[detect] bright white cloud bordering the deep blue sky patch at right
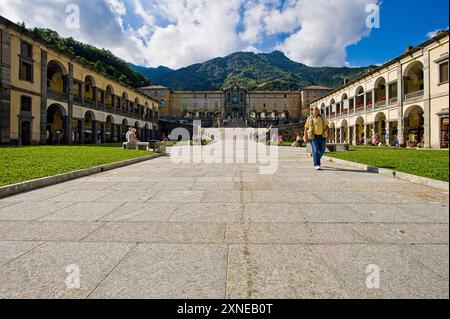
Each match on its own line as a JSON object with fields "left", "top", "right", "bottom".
{"left": 278, "top": 0, "right": 373, "bottom": 66}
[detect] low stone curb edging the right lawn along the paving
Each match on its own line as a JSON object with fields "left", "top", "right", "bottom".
{"left": 323, "top": 156, "right": 449, "bottom": 192}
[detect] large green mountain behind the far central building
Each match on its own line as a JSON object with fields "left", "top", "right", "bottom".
{"left": 130, "top": 51, "right": 375, "bottom": 91}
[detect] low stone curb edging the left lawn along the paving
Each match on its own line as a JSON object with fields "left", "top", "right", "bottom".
{"left": 0, "top": 154, "right": 162, "bottom": 198}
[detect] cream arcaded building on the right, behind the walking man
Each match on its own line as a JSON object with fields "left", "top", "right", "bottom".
{"left": 311, "top": 30, "right": 449, "bottom": 149}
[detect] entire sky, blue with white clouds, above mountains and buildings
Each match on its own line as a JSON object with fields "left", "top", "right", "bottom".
{"left": 0, "top": 0, "right": 449, "bottom": 68}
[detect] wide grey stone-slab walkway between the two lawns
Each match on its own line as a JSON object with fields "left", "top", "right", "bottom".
{"left": 0, "top": 148, "right": 449, "bottom": 298}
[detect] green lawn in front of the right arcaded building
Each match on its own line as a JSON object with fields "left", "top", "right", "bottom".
{"left": 326, "top": 148, "right": 449, "bottom": 182}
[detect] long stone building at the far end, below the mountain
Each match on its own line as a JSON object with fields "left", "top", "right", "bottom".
{"left": 139, "top": 85, "right": 330, "bottom": 127}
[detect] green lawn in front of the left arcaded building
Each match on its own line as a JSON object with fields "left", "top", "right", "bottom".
{"left": 0, "top": 144, "right": 152, "bottom": 186}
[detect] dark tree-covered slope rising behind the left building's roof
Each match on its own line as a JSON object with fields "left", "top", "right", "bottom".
{"left": 29, "top": 28, "right": 149, "bottom": 88}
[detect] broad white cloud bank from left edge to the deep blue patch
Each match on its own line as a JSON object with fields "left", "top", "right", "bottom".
{"left": 0, "top": 0, "right": 377, "bottom": 68}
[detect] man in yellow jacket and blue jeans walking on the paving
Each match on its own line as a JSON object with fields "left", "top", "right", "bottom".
{"left": 304, "top": 106, "right": 329, "bottom": 170}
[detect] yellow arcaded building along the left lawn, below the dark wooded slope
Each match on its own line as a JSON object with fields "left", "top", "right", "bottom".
{"left": 0, "top": 17, "right": 159, "bottom": 145}
